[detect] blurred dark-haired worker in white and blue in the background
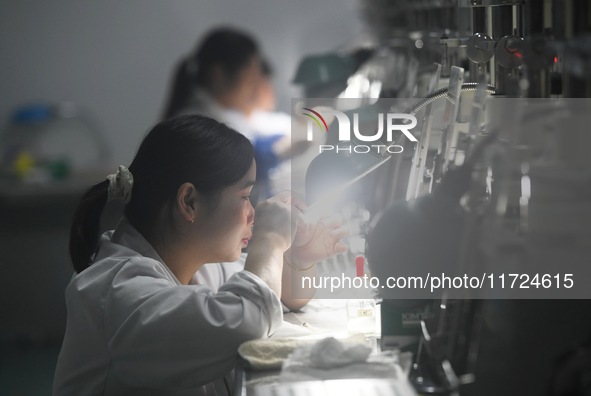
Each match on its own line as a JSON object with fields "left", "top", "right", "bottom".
{"left": 164, "top": 27, "right": 308, "bottom": 200}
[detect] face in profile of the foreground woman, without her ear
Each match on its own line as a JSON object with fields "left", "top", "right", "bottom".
{"left": 199, "top": 160, "right": 256, "bottom": 262}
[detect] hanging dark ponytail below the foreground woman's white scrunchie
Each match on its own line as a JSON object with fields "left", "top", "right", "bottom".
{"left": 70, "top": 180, "right": 109, "bottom": 273}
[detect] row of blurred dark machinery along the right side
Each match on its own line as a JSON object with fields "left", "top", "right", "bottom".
{"left": 296, "top": 0, "right": 591, "bottom": 395}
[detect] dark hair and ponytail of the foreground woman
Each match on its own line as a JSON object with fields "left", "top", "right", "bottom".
{"left": 70, "top": 115, "right": 254, "bottom": 273}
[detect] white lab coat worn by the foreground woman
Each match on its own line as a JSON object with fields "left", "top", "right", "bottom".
{"left": 53, "top": 221, "right": 282, "bottom": 396}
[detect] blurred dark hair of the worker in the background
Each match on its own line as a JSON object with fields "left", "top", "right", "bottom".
{"left": 163, "top": 27, "right": 259, "bottom": 119}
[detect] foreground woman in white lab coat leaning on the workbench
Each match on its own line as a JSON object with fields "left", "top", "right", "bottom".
{"left": 53, "top": 116, "right": 350, "bottom": 396}
